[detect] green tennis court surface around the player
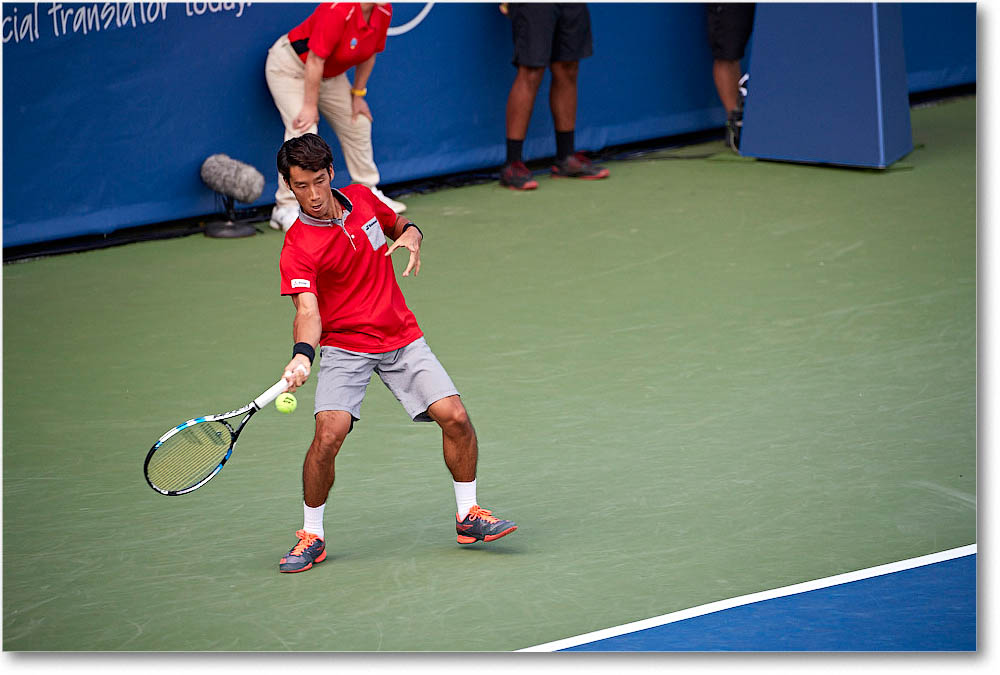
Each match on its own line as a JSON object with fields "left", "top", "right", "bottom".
{"left": 3, "top": 99, "right": 976, "bottom": 651}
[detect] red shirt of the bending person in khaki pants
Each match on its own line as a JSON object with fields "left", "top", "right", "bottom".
{"left": 288, "top": 2, "right": 392, "bottom": 77}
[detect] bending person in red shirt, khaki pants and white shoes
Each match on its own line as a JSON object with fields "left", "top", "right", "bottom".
{"left": 264, "top": 2, "right": 406, "bottom": 230}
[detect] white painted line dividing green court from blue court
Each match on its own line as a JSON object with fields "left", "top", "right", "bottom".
{"left": 517, "top": 544, "right": 976, "bottom": 652}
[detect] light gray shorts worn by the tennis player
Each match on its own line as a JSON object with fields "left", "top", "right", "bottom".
{"left": 313, "top": 337, "right": 458, "bottom": 422}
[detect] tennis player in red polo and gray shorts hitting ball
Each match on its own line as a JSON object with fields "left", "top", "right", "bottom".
{"left": 277, "top": 133, "right": 517, "bottom": 572}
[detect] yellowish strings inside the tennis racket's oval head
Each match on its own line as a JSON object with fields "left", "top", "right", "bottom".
{"left": 147, "top": 421, "right": 232, "bottom": 491}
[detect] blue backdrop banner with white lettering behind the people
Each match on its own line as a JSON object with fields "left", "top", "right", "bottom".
{"left": 2, "top": 2, "right": 976, "bottom": 247}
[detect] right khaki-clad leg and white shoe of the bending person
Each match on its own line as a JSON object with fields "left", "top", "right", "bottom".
{"left": 319, "top": 75, "right": 406, "bottom": 213}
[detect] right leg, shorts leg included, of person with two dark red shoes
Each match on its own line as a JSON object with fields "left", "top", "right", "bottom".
{"left": 549, "top": 3, "right": 609, "bottom": 180}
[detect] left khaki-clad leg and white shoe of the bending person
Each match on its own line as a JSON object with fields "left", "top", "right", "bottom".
{"left": 264, "top": 35, "right": 316, "bottom": 230}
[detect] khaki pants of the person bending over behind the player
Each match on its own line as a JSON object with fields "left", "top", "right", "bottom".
{"left": 264, "top": 34, "right": 379, "bottom": 207}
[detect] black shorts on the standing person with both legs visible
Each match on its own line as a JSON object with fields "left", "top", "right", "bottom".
{"left": 507, "top": 2, "right": 594, "bottom": 68}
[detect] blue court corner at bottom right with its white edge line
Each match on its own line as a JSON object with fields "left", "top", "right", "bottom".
{"left": 524, "top": 545, "right": 976, "bottom": 652}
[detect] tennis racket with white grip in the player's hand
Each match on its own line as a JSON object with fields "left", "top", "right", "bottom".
{"left": 142, "top": 366, "right": 305, "bottom": 495}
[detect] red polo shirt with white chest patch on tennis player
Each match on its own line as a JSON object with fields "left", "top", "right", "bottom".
{"left": 279, "top": 185, "right": 423, "bottom": 354}
